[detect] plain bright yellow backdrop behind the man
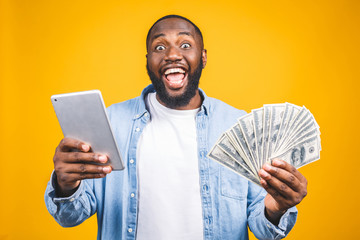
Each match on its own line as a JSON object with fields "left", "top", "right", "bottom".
{"left": 0, "top": 0, "right": 360, "bottom": 240}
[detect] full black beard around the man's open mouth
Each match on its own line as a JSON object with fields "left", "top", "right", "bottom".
{"left": 146, "top": 58, "right": 203, "bottom": 109}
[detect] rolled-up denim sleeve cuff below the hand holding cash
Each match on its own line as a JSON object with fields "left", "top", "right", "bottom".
{"left": 247, "top": 183, "right": 297, "bottom": 239}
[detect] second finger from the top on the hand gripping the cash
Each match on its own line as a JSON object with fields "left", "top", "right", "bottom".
{"left": 263, "top": 163, "right": 301, "bottom": 191}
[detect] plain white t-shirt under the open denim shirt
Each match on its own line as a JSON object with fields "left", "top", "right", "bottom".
{"left": 136, "top": 93, "right": 203, "bottom": 240}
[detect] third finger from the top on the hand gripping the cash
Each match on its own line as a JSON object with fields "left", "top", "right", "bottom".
{"left": 259, "top": 169, "right": 296, "bottom": 199}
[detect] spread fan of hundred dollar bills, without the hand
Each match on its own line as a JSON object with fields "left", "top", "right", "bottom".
{"left": 208, "top": 103, "right": 321, "bottom": 185}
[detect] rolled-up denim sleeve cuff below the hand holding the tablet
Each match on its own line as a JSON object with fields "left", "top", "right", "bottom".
{"left": 45, "top": 172, "right": 96, "bottom": 227}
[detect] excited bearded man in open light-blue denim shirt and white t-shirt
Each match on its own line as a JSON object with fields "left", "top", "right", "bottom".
{"left": 45, "top": 15, "right": 307, "bottom": 240}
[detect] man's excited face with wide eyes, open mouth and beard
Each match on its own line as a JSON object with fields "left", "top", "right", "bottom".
{"left": 147, "top": 18, "right": 206, "bottom": 108}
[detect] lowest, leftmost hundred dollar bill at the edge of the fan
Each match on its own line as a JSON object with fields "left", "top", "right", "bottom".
{"left": 208, "top": 145, "right": 261, "bottom": 186}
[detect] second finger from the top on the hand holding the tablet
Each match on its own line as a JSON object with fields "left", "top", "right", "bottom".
{"left": 55, "top": 152, "right": 108, "bottom": 163}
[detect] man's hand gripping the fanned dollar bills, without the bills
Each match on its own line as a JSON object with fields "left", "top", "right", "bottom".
{"left": 259, "top": 158, "right": 307, "bottom": 225}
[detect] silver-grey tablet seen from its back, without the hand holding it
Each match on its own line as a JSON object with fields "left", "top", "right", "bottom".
{"left": 51, "top": 90, "right": 124, "bottom": 170}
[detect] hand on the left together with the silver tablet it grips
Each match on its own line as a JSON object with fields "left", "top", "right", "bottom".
{"left": 51, "top": 90, "right": 124, "bottom": 196}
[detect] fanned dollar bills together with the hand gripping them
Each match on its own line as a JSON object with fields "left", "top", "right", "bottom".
{"left": 208, "top": 103, "right": 321, "bottom": 224}
